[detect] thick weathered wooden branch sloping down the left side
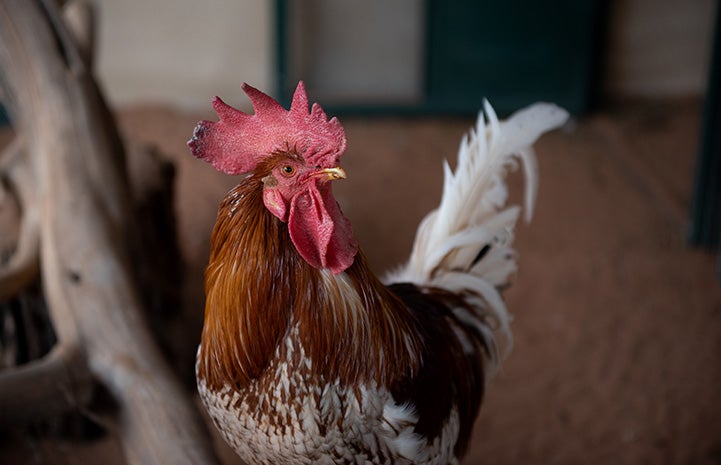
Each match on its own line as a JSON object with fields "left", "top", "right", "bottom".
{"left": 0, "top": 0, "right": 217, "bottom": 464}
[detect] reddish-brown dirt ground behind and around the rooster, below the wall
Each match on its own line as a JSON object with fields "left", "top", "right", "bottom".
{"left": 0, "top": 96, "right": 721, "bottom": 465}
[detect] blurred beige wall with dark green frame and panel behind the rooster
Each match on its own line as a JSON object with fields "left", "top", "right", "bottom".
{"left": 96, "top": 0, "right": 717, "bottom": 113}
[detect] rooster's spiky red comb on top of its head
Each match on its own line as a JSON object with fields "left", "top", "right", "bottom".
{"left": 188, "top": 81, "right": 346, "bottom": 174}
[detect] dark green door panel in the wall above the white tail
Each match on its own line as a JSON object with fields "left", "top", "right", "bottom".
{"left": 426, "top": 0, "right": 604, "bottom": 114}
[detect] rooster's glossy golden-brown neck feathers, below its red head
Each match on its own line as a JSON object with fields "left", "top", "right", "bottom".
{"left": 198, "top": 176, "right": 421, "bottom": 389}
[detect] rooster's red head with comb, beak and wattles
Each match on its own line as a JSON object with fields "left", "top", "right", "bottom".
{"left": 188, "top": 82, "right": 358, "bottom": 273}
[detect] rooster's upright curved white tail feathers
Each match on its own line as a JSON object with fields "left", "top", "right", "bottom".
{"left": 385, "top": 101, "right": 568, "bottom": 374}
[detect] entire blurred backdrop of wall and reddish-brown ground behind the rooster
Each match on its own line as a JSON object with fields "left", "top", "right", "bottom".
{"left": 0, "top": 0, "right": 721, "bottom": 465}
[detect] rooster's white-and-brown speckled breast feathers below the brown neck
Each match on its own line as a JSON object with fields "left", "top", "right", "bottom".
{"left": 198, "top": 327, "right": 458, "bottom": 465}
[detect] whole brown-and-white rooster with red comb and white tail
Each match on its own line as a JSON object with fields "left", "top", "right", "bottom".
{"left": 188, "top": 82, "right": 567, "bottom": 465}
